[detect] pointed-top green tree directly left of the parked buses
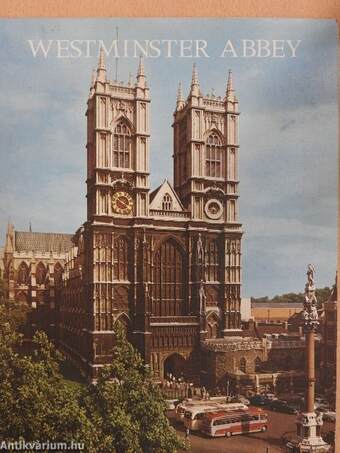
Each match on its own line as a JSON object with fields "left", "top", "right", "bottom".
{"left": 85, "top": 329, "right": 185, "bottom": 453}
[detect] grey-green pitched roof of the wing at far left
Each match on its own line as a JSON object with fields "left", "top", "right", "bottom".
{"left": 15, "top": 231, "right": 73, "bottom": 253}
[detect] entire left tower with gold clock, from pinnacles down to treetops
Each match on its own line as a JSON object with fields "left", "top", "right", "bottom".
{"left": 78, "top": 50, "right": 150, "bottom": 375}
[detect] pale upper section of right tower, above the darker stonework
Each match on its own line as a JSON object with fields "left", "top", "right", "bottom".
{"left": 173, "top": 65, "right": 239, "bottom": 223}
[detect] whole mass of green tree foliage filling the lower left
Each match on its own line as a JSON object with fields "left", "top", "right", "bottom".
{"left": 0, "top": 274, "right": 184, "bottom": 453}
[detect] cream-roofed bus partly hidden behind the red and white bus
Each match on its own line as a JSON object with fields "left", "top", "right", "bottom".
{"left": 184, "top": 401, "right": 248, "bottom": 431}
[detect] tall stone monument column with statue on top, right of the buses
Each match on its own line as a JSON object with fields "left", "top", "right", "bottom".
{"left": 287, "top": 264, "right": 330, "bottom": 453}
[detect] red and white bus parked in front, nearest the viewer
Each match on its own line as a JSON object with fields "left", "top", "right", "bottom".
{"left": 200, "top": 407, "right": 268, "bottom": 437}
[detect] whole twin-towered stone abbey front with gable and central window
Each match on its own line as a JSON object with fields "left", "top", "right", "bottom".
{"left": 56, "top": 52, "right": 242, "bottom": 379}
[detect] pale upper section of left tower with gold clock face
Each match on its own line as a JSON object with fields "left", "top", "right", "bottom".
{"left": 87, "top": 50, "right": 150, "bottom": 223}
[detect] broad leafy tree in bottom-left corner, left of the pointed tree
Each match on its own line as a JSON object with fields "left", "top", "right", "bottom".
{"left": 0, "top": 323, "right": 101, "bottom": 453}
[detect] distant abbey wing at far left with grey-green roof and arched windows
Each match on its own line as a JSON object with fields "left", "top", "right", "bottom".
{"left": 1, "top": 224, "right": 72, "bottom": 338}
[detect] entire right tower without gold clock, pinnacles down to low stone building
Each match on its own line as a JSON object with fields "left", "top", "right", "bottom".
{"left": 173, "top": 64, "right": 242, "bottom": 336}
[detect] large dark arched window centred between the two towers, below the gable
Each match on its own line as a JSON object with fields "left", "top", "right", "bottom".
{"left": 153, "top": 239, "right": 183, "bottom": 316}
